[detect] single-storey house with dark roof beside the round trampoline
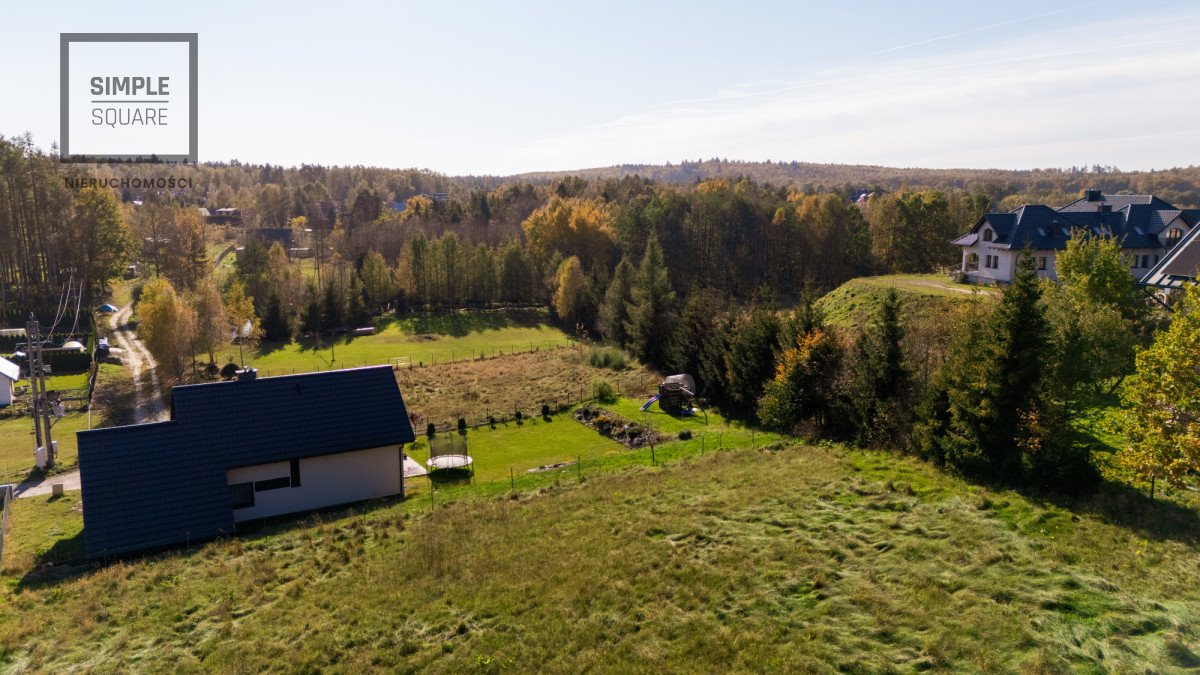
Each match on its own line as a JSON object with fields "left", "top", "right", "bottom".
{"left": 78, "top": 366, "right": 414, "bottom": 557}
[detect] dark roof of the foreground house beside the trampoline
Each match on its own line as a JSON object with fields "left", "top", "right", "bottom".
{"left": 78, "top": 366, "right": 414, "bottom": 557}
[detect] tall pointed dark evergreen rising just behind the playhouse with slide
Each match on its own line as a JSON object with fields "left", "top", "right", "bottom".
{"left": 625, "top": 233, "right": 676, "bottom": 365}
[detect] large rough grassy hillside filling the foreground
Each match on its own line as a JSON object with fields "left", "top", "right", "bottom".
{"left": 0, "top": 432, "right": 1200, "bottom": 671}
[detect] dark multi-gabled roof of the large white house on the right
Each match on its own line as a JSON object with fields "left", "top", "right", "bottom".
{"left": 954, "top": 191, "right": 1198, "bottom": 250}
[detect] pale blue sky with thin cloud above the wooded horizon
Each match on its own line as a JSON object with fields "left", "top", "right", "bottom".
{"left": 0, "top": 0, "right": 1200, "bottom": 175}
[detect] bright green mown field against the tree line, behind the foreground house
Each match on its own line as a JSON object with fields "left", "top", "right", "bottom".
{"left": 242, "top": 310, "right": 574, "bottom": 375}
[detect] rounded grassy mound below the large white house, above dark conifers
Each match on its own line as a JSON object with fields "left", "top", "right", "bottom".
{"left": 817, "top": 274, "right": 996, "bottom": 327}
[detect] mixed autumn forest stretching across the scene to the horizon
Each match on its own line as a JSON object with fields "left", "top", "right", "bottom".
{"left": 0, "top": 132, "right": 1200, "bottom": 489}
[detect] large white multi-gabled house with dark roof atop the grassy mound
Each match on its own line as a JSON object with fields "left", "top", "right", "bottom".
{"left": 954, "top": 190, "right": 1200, "bottom": 283}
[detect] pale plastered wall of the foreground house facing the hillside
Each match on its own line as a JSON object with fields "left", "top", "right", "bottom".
{"left": 226, "top": 446, "right": 403, "bottom": 522}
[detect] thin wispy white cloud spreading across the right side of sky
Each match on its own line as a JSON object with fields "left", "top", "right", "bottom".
{"left": 490, "top": 16, "right": 1200, "bottom": 172}
